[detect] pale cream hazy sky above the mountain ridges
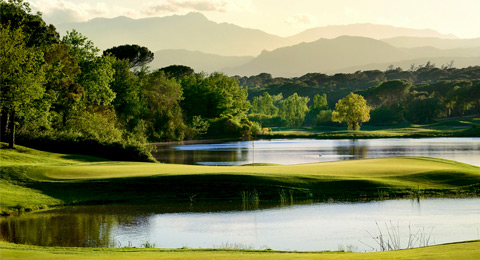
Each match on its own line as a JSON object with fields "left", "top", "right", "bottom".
{"left": 27, "top": 0, "right": 480, "bottom": 38}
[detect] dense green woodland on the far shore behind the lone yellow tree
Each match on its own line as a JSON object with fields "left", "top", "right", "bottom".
{"left": 244, "top": 66, "right": 480, "bottom": 126}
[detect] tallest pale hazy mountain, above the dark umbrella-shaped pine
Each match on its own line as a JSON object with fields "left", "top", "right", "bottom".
{"left": 57, "top": 13, "right": 292, "bottom": 56}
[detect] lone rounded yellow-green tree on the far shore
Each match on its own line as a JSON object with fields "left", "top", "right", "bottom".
{"left": 332, "top": 93, "right": 370, "bottom": 130}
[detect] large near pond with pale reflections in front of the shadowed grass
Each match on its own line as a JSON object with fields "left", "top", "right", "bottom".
{"left": 0, "top": 198, "right": 480, "bottom": 252}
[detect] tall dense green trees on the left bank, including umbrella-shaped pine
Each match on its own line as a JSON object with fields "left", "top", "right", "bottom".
{"left": 0, "top": 0, "right": 259, "bottom": 160}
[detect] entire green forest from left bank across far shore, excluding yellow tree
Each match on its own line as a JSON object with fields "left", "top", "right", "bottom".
{"left": 0, "top": 0, "right": 480, "bottom": 160}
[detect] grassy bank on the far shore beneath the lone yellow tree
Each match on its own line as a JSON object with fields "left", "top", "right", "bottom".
{"left": 262, "top": 117, "right": 480, "bottom": 139}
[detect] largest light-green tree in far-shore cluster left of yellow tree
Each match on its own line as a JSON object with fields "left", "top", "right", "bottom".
{"left": 279, "top": 93, "right": 310, "bottom": 126}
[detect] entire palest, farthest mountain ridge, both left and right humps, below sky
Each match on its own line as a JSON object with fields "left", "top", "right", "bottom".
{"left": 57, "top": 12, "right": 464, "bottom": 56}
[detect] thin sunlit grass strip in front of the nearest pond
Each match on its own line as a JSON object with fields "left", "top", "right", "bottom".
{"left": 0, "top": 241, "right": 480, "bottom": 260}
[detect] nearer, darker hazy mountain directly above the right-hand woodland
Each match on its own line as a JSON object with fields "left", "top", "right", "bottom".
{"left": 222, "top": 36, "right": 480, "bottom": 77}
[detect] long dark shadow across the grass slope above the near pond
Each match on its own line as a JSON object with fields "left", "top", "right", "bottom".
{"left": 27, "top": 174, "right": 404, "bottom": 204}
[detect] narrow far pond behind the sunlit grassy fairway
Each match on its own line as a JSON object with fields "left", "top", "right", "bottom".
{"left": 154, "top": 137, "right": 480, "bottom": 166}
